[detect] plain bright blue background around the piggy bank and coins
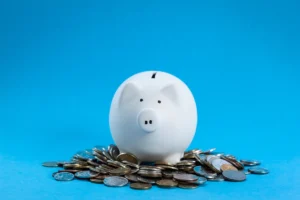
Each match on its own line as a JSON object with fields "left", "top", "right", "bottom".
{"left": 0, "top": 0, "right": 300, "bottom": 200}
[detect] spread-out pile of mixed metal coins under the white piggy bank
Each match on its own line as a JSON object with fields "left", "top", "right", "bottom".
{"left": 43, "top": 144, "right": 269, "bottom": 190}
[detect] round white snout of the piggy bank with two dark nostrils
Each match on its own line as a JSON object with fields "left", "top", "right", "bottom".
{"left": 138, "top": 109, "right": 158, "bottom": 133}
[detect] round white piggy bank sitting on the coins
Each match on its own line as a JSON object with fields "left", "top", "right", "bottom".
{"left": 109, "top": 71, "right": 197, "bottom": 164}
